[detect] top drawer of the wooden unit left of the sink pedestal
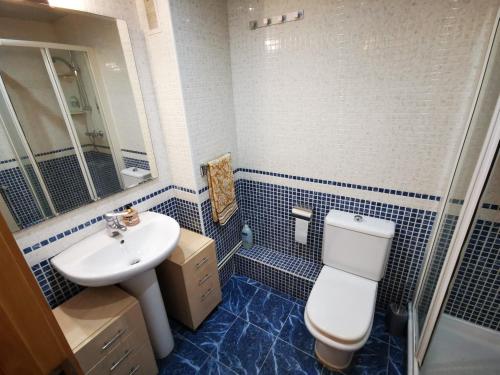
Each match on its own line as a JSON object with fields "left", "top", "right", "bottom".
{"left": 75, "top": 304, "right": 143, "bottom": 372}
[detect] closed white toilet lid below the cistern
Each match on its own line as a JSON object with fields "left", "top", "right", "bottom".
{"left": 306, "top": 266, "right": 377, "bottom": 343}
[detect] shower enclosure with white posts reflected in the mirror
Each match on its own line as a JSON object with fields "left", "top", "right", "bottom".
{"left": 0, "top": 39, "right": 124, "bottom": 229}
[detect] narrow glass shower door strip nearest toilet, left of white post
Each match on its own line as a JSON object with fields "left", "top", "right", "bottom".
{"left": 414, "top": 18, "right": 500, "bottom": 368}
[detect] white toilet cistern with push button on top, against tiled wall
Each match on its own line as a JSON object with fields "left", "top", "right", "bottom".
{"left": 323, "top": 210, "right": 396, "bottom": 281}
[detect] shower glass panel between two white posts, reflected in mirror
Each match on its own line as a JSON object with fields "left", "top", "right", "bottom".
{"left": 0, "top": 46, "right": 92, "bottom": 212}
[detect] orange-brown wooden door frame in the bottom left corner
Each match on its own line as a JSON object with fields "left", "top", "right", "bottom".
{"left": 0, "top": 214, "right": 83, "bottom": 375}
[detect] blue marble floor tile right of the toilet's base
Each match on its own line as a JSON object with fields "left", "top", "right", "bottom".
{"left": 342, "top": 337, "right": 389, "bottom": 375}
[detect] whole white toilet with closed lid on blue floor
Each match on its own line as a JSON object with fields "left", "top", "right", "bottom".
{"left": 304, "top": 210, "right": 396, "bottom": 369}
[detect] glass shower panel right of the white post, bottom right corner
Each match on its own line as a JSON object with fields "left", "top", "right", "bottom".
{"left": 420, "top": 154, "right": 500, "bottom": 375}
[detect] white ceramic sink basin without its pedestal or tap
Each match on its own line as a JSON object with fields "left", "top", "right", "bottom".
{"left": 52, "top": 212, "right": 180, "bottom": 287}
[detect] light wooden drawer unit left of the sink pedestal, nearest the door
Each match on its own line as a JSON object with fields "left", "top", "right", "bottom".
{"left": 53, "top": 286, "right": 158, "bottom": 375}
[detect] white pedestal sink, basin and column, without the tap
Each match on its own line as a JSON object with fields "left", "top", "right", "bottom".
{"left": 52, "top": 212, "right": 180, "bottom": 358}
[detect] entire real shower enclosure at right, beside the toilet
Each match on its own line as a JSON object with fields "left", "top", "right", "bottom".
{"left": 408, "top": 17, "right": 500, "bottom": 375}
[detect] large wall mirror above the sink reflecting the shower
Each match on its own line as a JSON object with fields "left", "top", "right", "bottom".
{"left": 0, "top": 2, "right": 157, "bottom": 231}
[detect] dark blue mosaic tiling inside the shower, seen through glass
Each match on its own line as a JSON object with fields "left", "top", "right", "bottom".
{"left": 417, "top": 206, "right": 500, "bottom": 331}
